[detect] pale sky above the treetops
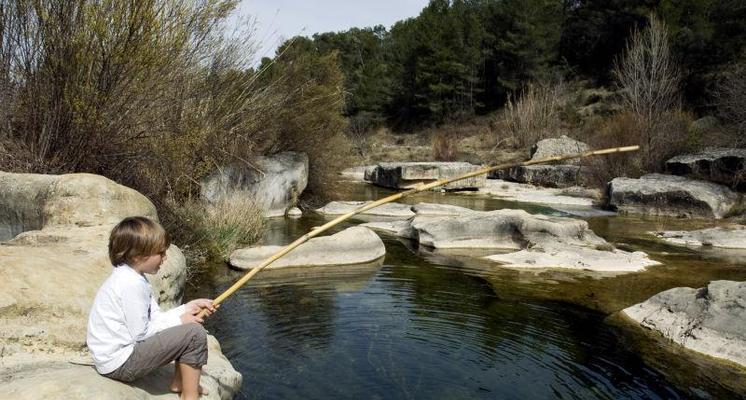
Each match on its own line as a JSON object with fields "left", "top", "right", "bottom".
{"left": 238, "top": 0, "right": 428, "bottom": 61}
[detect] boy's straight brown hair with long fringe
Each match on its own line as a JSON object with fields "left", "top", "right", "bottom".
{"left": 109, "top": 217, "right": 171, "bottom": 267}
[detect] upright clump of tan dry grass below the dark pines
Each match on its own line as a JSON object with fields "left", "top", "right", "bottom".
{"left": 503, "top": 81, "right": 569, "bottom": 147}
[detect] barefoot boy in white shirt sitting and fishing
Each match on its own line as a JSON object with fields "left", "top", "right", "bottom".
{"left": 86, "top": 217, "right": 215, "bottom": 399}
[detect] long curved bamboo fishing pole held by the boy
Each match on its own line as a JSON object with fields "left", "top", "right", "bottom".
{"left": 198, "top": 146, "right": 640, "bottom": 317}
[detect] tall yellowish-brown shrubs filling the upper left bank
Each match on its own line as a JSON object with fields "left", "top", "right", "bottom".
{"left": 0, "top": 0, "right": 350, "bottom": 255}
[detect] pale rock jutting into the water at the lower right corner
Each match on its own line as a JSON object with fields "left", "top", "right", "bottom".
{"left": 622, "top": 281, "right": 746, "bottom": 367}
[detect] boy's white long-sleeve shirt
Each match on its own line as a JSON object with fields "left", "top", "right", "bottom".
{"left": 86, "top": 264, "right": 186, "bottom": 374}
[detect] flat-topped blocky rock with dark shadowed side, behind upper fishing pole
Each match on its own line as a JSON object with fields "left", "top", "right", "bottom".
{"left": 365, "top": 162, "right": 486, "bottom": 190}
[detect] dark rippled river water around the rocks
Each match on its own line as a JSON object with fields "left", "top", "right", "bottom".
{"left": 188, "top": 183, "right": 746, "bottom": 399}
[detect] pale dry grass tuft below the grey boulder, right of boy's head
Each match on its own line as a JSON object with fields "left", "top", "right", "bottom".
{"left": 163, "top": 194, "right": 265, "bottom": 260}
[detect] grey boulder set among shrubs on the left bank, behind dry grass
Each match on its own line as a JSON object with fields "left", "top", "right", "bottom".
{"left": 200, "top": 152, "right": 308, "bottom": 217}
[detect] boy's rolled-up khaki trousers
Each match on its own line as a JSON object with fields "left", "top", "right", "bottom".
{"left": 104, "top": 323, "right": 207, "bottom": 382}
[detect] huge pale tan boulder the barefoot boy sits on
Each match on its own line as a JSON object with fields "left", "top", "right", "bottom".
{"left": 0, "top": 173, "right": 240, "bottom": 399}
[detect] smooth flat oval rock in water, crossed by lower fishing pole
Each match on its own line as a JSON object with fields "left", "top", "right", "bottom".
{"left": 230, "top": 227, "right": 386, "bottom": 270}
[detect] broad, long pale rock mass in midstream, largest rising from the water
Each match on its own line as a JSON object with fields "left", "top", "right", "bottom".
{"left": 363, "top": 205, "right": 659, "bottom": 273}
